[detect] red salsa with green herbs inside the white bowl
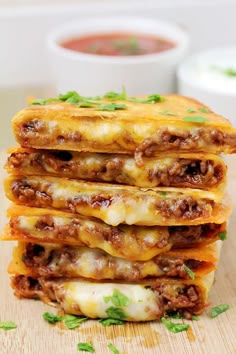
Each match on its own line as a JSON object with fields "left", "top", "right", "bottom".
{"left": 60, "top": 33, "right": 176, "bottom": 56}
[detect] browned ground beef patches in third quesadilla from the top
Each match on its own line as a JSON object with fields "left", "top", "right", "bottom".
{"left": 11, "top": 179, "right": 214, "bottom": 220}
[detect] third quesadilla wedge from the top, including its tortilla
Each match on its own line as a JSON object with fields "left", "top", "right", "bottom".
{"left": 5, "top": 176, "right": 230, "bottom": 226}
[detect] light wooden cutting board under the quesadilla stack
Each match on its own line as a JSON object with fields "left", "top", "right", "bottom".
{"left": 0, "top": 152, "right": 236, "bottom": 354}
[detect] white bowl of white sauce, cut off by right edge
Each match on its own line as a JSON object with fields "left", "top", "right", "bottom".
{"left": 177, "top": 47, "right": 236, "bottom": 126}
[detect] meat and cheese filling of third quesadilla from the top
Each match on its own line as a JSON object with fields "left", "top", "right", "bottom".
{"left": 11, "top": 177, "right": 215, "bottom": 226}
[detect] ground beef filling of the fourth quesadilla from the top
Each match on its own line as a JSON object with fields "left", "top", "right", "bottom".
{"left": 9, "top": 214, "right": 222, "bottom": 250}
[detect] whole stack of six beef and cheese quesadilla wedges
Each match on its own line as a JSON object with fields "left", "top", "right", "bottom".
{"left": 2, "top": 92, "right": 236, "bottom": 321}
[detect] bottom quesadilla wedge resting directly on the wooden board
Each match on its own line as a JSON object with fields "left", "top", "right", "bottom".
{"left": 11, "top": 272, "right": 214, "bottom": 321}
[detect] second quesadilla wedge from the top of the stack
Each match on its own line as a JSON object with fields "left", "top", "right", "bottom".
{"left": 5, "top": 147, "right": 227, "bottom": 190}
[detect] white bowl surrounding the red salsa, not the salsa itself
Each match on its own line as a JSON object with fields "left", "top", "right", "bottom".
{"left": 47, "top": 17, "right": 188, "bottom": 96}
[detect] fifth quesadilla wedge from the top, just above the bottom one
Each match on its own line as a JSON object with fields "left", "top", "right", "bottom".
{"left": 8, "top": 242, "right": 218, "bottom": 282}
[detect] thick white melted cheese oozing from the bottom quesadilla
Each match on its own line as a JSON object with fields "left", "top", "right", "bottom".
{"left": 55, "top": 281, "right": 160, "bottom": 321}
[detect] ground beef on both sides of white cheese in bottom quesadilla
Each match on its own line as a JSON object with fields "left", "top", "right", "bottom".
{"left": 11, "top": 275, "right": 203, "bottom": 319}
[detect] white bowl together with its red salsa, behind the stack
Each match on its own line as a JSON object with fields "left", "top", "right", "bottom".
{"left": 47, "top": 17, "right": 188, "bottom": 95}
